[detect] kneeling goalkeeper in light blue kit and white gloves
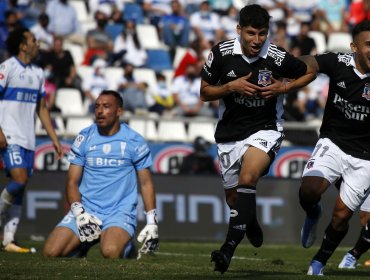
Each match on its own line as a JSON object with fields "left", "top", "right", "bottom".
{"left": 44, "top": 90, "right": 158, "bottom": 258}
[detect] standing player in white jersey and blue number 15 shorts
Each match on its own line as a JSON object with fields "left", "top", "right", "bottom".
{"left": 0, "top": 28, "right": 63, "bottom": 253}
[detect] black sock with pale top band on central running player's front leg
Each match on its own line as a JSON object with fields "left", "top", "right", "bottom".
{"left": 221, "top": 185, "right": 256, "bottom": 256}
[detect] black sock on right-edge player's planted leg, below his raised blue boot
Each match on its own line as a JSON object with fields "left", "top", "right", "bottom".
{"left": 313, "top": 224, "right": 348, "bottom": 265}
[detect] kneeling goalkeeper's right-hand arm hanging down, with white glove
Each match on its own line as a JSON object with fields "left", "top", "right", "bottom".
{"left": 137, "top": 168, "right": 159, "bottom": 254}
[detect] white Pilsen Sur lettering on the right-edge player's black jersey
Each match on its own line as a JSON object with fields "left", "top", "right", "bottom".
{"left": 333, "top": 93, "right": 370, "bottom": 121}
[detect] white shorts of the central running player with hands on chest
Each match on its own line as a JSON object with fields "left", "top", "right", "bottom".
{"left": 217, "top": 130, "right": 284, "bottom": 189}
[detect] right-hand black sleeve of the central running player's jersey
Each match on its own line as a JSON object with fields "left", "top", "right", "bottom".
{"left": 277, "top": 48, "right": 307, "bottom": 79}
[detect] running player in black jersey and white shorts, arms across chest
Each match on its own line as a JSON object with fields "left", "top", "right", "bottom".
{"left": 200, "top": 5, "right": 315, "bottom": 273}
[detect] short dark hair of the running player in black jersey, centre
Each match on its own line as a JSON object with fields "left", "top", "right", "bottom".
{"left": 239, "top": 4, "right": 271, "bottom": 28}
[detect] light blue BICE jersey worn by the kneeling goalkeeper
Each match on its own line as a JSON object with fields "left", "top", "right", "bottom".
{"left": 68, "top": 124, "right": 152, "bottom": 217}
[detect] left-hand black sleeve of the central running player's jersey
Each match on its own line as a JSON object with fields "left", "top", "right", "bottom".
{"left": 200, "top": 45, "right": 222, "bottom": 85}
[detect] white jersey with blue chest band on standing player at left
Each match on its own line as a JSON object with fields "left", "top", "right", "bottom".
{"left": 0, "top": 57, "right": 45, "bottom": 150}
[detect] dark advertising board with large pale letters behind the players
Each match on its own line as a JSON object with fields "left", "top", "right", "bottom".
{"left": 0, "top": 171, "right": 360, "bottom": 245}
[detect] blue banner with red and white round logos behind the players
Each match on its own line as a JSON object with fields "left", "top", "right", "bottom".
{"left": 35, "top": 138, "right": 313, "bottom": 178}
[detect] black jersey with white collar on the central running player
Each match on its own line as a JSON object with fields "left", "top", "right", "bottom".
{"left": 201, "top": 38, "right": 307, "bottom": 143}
